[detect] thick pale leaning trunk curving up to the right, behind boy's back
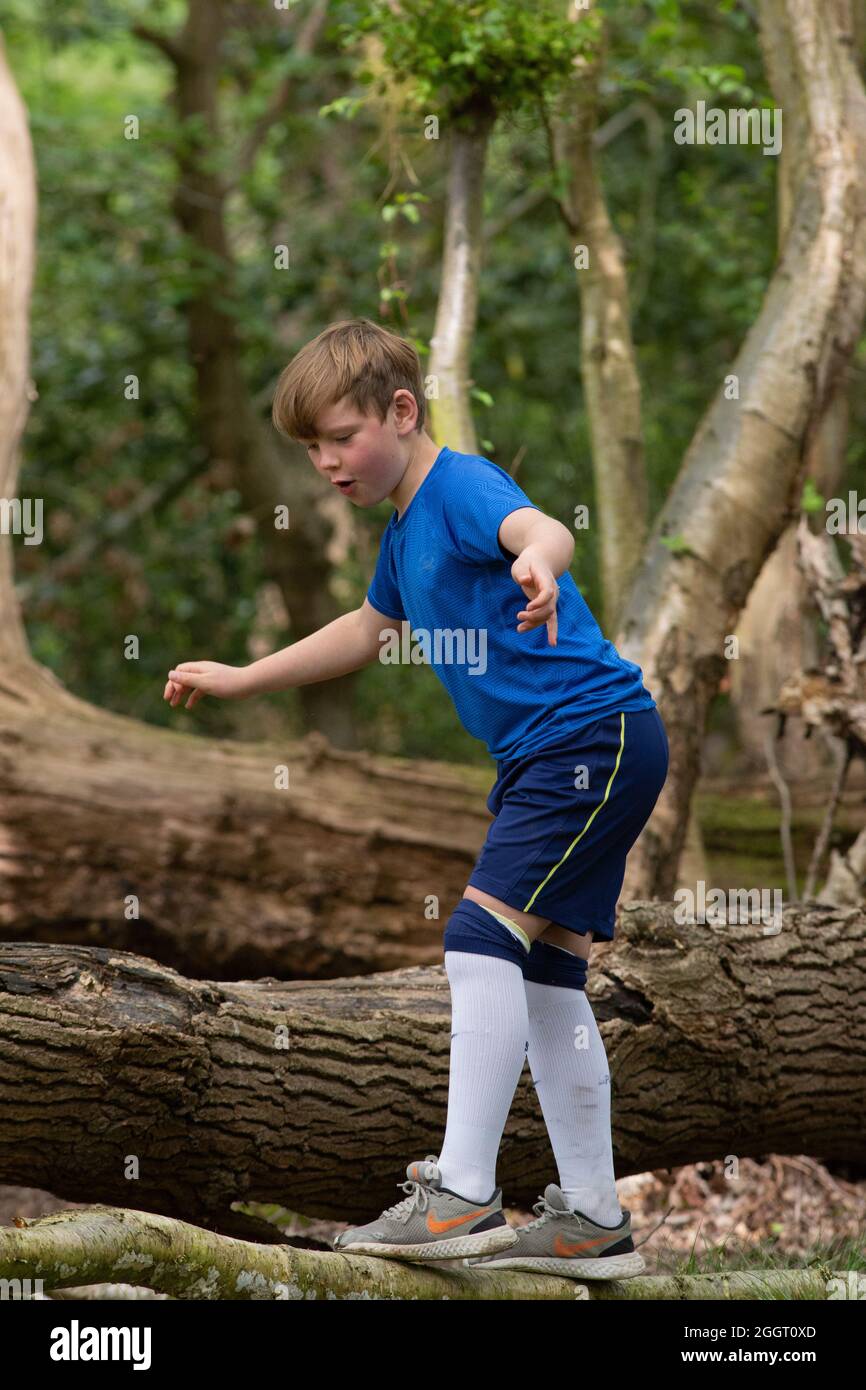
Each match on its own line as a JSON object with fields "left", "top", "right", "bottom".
{"left": 616, "top": 0, "right": 866, "bottom": 898}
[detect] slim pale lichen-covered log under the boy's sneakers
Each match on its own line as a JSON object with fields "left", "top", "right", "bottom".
{"left": 0, "top": 1207, "right": 849, "bottom": 1302}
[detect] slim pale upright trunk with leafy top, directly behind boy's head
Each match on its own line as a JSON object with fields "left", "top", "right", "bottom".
{"left": 430, "top": 107, "right": 495, "bottom": 453}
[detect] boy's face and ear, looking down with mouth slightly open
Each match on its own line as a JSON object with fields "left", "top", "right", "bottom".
{"left": 300, "top": 391, "right": 417, "bottom": 507}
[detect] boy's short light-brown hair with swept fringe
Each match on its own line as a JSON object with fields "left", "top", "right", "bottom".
{"left": 271, "top": 318, "right": 425, "bottom": 439}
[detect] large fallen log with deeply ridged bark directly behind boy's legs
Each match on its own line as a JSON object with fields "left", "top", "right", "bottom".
{"left": 0, "top": 902, "right": 866, "bottom": 1230}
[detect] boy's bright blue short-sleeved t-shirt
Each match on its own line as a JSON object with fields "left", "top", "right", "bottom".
{"left": 367, "top": 448, "right": 655, "bottom": 762}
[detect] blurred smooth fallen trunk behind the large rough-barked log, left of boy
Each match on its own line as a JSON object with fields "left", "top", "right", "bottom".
{"left": 0, "top": 717, "right": 491, "bottom": 980}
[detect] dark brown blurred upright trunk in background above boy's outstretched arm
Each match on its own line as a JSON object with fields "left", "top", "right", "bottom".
{"left": 132, "top": 0, "right": 357, "bottom": 748}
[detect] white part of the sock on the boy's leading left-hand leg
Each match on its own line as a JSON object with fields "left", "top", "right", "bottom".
{"left": 438, "top": 951, "right": 528, "bottom": 1202}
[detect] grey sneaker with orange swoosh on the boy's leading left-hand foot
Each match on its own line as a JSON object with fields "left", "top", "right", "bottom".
{"left": 332, "top": 1154, "right": 517, "bottom": 1259}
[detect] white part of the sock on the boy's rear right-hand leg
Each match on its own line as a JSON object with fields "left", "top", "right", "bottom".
{"left": 524, "top": 980, "right": 623, "bottom": 1226}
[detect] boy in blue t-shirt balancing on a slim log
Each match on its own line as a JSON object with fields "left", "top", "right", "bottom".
{"left": 165, "top": 318, "right": 667, "bottom": 1279}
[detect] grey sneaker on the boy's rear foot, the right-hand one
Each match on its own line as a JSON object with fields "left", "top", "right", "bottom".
{"left": 463, "top": 1183, "right": 646, "bottom": 1279}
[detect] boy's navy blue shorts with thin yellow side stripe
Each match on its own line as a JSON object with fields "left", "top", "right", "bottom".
{"left": 468, "top": 706, "right": 669, "bottom": 941}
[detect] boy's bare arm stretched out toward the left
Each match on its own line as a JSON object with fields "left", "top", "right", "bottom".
{"left": 164, "top": 599, "right": 400, "bottom": 709}
